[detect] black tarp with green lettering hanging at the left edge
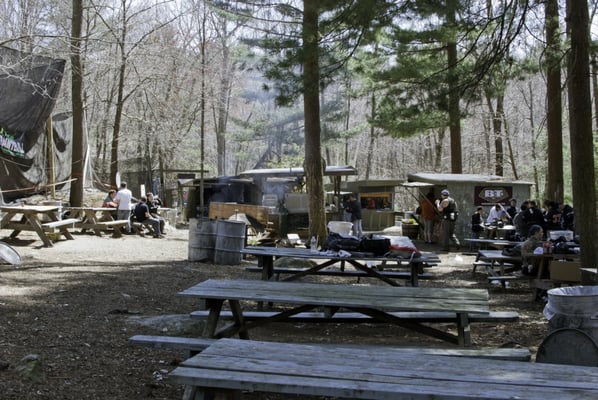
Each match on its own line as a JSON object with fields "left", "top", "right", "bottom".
{"left": 0, "top": 46, "right": 70, "bottom": 200}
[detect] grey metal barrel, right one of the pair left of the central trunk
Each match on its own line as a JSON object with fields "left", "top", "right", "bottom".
{"left": 214, "top": 219, "right": 245, "bottom": 265}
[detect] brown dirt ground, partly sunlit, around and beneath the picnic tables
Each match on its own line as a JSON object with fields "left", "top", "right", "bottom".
{"left": 0, "top": 222, "right": 547, "bottom": 400}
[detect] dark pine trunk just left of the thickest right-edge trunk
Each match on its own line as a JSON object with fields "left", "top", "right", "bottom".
{"left": 544, "top": 0, "right": 564, "bottom": 203}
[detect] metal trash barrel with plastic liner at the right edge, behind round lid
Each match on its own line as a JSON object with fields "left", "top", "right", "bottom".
{"left": 544, "top": 286, "right": 598, "bottom": 342}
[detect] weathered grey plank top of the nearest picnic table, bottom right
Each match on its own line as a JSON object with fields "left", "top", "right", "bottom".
{"left": 169, "top": 339, "right": 598, "bottom": 400}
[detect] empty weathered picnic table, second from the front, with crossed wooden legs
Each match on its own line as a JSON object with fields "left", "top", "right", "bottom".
{"left": 179, "top": 279, "right": 490, "bottom": 347}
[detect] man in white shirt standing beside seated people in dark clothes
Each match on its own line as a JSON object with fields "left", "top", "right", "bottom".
{"left": 102, "top": 182, "right": 166, "bottom": 238}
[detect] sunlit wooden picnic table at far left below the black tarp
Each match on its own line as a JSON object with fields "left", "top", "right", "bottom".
{"left": 0, "top": 204, "right": 79, "bottom": 247}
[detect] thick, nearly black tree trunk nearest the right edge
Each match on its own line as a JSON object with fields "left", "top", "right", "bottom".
{"left": 566, "top": 0, "right": 598, "bottom": 268}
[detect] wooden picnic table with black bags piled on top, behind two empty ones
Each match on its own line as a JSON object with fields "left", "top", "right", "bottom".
{"left": 241, "top": 246, "right": 439, "bottom": 286}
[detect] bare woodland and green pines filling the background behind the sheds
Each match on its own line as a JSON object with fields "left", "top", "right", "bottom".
{"left": 0, "top": 0, "right": 598, "bottom": 266}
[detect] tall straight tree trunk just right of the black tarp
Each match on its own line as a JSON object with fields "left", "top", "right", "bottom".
{"left": 69, "top": 0, "right": 84, "bottom": 207}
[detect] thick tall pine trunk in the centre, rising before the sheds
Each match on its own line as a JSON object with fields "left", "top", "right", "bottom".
{"left": 303, "top": 0, "right": 326, "bottom": 244}
